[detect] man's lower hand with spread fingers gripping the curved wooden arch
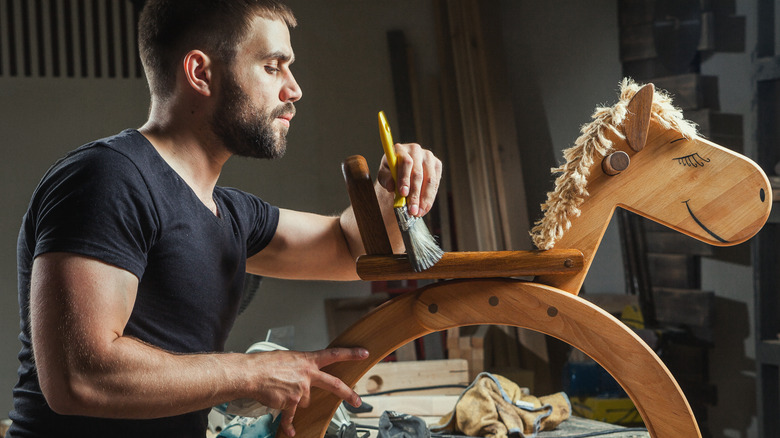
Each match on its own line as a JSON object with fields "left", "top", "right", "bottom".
{"left": 251, "top": 348, "right": 368, "bottom": 437}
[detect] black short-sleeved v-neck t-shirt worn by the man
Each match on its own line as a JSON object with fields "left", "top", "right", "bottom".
{"left": 9, "top": 130, "right": 279, "bottom": 437}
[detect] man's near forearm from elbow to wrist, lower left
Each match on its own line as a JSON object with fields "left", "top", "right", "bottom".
{"left": 38, "top": 336, "right": 260, "bottom": 418}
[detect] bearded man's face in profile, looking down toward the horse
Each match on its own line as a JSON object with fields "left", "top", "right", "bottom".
{"left": 211, "top": 17, "right": 301, "bottom": 159}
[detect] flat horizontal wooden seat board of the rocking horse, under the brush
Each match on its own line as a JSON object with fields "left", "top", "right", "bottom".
{"left": 357, "top": 249, "right": 584, "bottom": 280}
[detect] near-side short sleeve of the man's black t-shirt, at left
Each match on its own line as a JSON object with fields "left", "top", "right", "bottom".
{"left": 29, "top": 145, "right": 158, "bottom": 279}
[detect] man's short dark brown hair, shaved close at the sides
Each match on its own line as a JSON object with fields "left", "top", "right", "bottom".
{"left": 138, "top": 0, "right": 297, "bottom": 98}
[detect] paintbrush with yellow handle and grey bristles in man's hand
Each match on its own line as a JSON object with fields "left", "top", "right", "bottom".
{"left": 379, "top": 111, "right": 444, "bottom": 272}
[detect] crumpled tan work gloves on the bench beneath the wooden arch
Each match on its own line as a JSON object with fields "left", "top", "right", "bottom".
{"left": 431, "top": 373, "right": 571, "bottom": 438}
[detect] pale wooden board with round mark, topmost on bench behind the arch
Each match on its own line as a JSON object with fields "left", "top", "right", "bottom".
{"left": 354, "top": 359, "right": 470, "bottom": 396}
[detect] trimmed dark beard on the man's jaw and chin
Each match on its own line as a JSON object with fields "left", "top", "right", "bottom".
{"left": 211, "top": 71, "right": 295, "bottom": 159}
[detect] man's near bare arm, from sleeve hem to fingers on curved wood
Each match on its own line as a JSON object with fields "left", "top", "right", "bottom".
{"left": 30, "top": 253, "right": 367, "bottom": 430}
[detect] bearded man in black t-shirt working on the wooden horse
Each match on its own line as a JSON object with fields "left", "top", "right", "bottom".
{"left": 9, "top": 0, "right": 441, "bottom": 437}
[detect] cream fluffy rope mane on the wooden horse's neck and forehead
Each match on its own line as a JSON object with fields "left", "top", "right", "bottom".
{"left": 531, "top": 78, "right": 698, "bottom": 250}
